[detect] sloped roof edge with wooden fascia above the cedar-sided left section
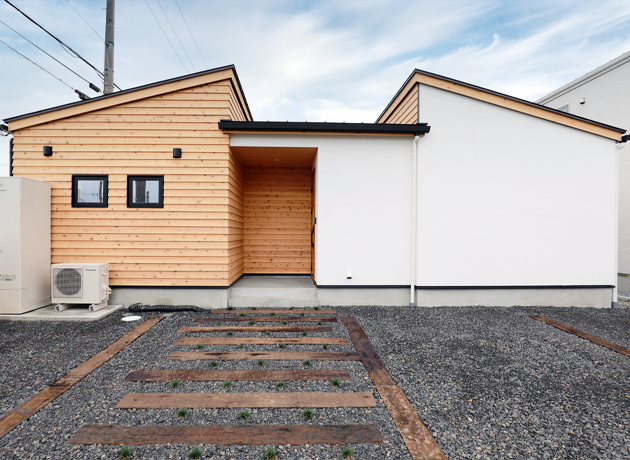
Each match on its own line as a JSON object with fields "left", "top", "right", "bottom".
{"left": 4, "top": 65, "right": 253, "bottom": 131}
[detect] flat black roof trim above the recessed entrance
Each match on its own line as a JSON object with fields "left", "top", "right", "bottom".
{"left": 219, "top": 120, "right": 431, "bottom": 134}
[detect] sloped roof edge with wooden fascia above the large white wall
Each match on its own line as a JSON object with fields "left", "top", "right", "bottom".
{"left": 376, "top": 69, "right": 626, "bottom": 141}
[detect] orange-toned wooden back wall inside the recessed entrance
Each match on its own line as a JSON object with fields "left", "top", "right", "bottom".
{"left": 244, "top": 167, "right": 311, "bottom": 273}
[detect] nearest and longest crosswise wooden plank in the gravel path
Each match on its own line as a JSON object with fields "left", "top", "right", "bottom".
{"left": 69, "top": 425, "right": 383, "bottom": 446}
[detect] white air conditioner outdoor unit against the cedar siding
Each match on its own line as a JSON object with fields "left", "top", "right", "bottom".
{"left": 50, "top": 264, "right": 110, "bottom": 311}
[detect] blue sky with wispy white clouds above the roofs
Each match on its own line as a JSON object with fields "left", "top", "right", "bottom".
{"left": 0, "top": 0, "right": 630, "bottom": 175}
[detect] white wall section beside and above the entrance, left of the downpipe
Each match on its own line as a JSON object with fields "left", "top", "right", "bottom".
{"left": 230, "top": 133, "right": 413, "bottom": 286}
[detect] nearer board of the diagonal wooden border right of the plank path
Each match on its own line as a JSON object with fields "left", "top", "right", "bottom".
{"left": 376, "top": 385, "right": 446, "bottom": 460}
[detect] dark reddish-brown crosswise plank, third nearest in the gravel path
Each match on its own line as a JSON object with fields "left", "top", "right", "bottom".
{"left": 125, "top": 369, "right": 350, "bottom": 382}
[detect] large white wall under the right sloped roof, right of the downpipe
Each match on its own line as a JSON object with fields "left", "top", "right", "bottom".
{"left": 418, "top": 85, "right": 616, "bottom": 286}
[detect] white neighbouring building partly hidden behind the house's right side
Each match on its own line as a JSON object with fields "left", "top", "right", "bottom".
{"left": 537, "top": 52, "right": 630, "bottom": 291}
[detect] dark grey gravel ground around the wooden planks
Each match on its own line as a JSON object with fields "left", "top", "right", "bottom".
{"left": 0, "top": 307, "right": 630, "bottom": 460}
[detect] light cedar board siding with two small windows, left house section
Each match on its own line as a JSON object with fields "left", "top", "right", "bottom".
{"left": 13, "top": 80, "right": 243, "bottom": 286}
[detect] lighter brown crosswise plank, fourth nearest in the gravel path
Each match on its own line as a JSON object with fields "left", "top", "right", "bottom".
{"left": 166, "top": 351, "right": 361, "bottom": 361}
